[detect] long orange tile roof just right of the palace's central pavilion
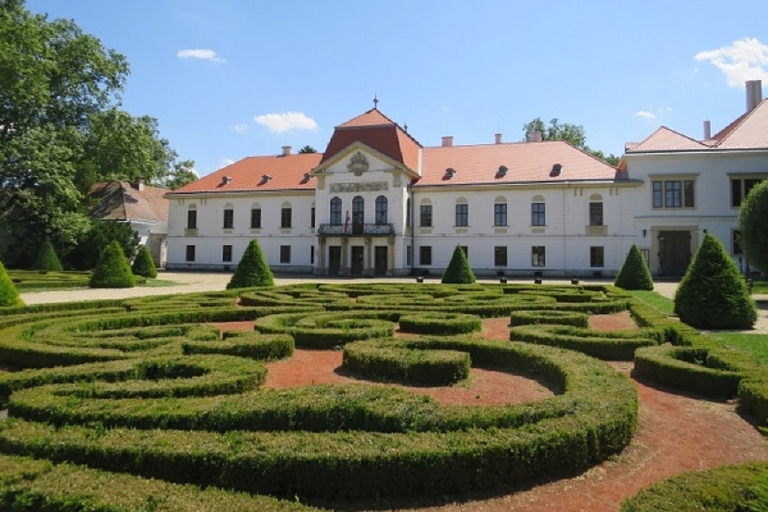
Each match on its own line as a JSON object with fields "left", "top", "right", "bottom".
{"left": 416, "top": 141, "right": 617, "bottom": 187}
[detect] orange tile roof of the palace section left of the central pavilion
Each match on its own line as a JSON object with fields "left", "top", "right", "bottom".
{"left": 172, "top": 153, "right": 323, "bottom": 194}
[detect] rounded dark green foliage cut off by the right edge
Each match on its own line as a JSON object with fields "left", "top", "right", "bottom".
{"left": 739, "top": 180, "right": 768, "bottom": 274}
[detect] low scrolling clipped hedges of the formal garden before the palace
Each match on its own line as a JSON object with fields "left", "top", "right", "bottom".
{"left": 0, "top": 284, "right": 760, "bottom": 511}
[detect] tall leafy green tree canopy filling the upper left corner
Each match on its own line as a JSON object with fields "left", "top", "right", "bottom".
{"left": 0, "top": 0, "right": 189, "bottom": 268}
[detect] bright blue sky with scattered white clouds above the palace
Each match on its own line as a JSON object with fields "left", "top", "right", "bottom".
{"left": 27, "top": 0, "right": 768, "bottom": 176}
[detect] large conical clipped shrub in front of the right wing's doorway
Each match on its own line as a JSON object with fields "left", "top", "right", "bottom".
{"left": 675, "top": 234, "right": 757, "bottom": 329}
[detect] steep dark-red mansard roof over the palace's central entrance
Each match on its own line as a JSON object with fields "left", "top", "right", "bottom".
{"left": 321, "top": 108, "right": 421, "bottom": 171}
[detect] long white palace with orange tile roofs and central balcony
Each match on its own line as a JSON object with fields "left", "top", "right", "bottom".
{"left": 166, "top": 81, "right": 768, "bottom": 277}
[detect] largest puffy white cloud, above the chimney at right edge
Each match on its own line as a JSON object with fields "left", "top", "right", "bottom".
{"left": 694, "top": 37, "right": 768, "bottom": 88}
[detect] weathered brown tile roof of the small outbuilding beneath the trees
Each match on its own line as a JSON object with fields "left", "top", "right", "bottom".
{"left": 88, "top": 181, "right": 168, "bottom": 223}
